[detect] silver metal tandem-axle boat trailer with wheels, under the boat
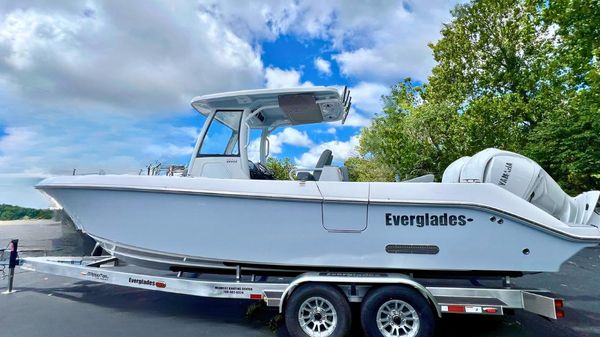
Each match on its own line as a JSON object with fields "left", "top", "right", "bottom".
{"left": 0, "top": 240, "right": 564, "bottom": 337}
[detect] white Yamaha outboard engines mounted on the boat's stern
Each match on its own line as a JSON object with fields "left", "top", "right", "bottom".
{"left": 442, "top": 148, "right": 600, "bottom": 226}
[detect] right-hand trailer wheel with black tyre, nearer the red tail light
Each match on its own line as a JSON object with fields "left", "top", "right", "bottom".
{"left": 360, "top": 286, "right": 435, "bottom": 337}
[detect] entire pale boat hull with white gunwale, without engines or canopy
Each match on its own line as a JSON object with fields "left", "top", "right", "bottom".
{"left": 38, "top": 176, "right": 600, "bottom": 273}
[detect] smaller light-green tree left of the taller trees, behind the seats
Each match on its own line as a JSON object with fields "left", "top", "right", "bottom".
{"left": 360, "top": 79, "right": 464, "bottom": 180}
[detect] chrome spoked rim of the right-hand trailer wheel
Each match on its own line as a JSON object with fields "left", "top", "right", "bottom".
{"left": 376, "top": 300, "right": 420, "bottom": 337}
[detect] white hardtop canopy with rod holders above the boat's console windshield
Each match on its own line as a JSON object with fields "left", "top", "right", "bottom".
{"left": 192, "top": 87, "right": 351, "bottom": 128}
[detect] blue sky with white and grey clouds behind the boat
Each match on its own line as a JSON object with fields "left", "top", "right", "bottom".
{"left": 0, "top": 0, "right": 456, "bottom": 207}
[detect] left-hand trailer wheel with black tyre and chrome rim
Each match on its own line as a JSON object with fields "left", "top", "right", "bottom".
{"left": 285, "top": 284, "right": 352, "bottom": 337}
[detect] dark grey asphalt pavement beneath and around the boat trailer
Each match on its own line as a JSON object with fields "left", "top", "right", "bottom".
{"left": 0, "top": 222, "right": 600, "bottom": 337}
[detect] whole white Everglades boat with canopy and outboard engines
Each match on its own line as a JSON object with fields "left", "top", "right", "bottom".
{"left": 36, "top": 87, "right": 600, "bottom": 276}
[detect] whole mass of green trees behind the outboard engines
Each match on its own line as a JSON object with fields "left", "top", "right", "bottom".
{"left": 351, "top": 0, "right": 600, "bottom": 193}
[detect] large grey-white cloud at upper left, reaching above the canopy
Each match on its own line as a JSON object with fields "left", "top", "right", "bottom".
{"left": 0, "top": 1, "right": 263, "bottom": 115}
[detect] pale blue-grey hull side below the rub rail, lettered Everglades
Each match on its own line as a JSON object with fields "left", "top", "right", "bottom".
{"left": 38, "top": 184, "right": 593, "bottom": 272}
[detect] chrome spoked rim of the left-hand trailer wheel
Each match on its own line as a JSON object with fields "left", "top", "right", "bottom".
{"left": 298, "top": 297, "right": 337, "bottom": 337}
